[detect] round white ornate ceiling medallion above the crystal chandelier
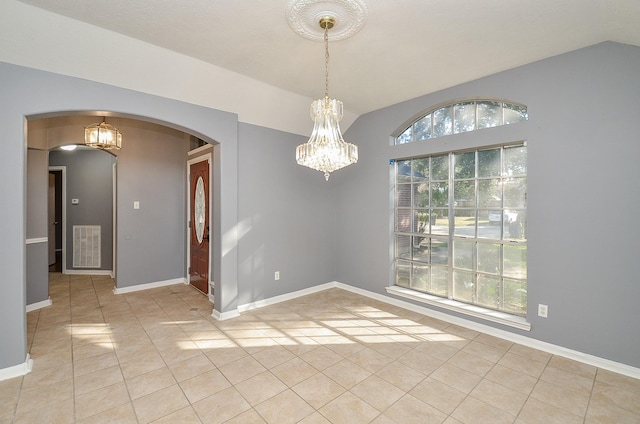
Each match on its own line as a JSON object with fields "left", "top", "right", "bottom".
{"left": 286, "top": 0, "right": 367, "bottom": 41}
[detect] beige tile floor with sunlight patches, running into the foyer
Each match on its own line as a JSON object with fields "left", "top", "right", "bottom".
{"left": 0, "top": 274, "right": 640, "bottom": 424}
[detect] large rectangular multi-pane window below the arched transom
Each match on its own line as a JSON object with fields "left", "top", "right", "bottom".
{"left": 394, "top": 142, "right": 527, "bottom": 316}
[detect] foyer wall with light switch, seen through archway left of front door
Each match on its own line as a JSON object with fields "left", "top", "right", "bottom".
{"left": 115, "top": 119, "right": 188, "bottom": 288}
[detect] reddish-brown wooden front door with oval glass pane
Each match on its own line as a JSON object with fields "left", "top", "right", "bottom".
{"left": 189, "top": 160, "right": 209, "bottom": 294}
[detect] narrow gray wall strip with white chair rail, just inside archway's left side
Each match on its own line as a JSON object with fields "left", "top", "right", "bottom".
{"left": 26, "top": 149, "right": 49, "bottom": 305}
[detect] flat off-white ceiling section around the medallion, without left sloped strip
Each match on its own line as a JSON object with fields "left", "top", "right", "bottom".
{"left": 15, "top": 0, "right": 640, "bottom": 115}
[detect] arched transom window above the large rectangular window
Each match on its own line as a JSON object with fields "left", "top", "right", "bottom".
{"left": 395, "top": 100, "right": 529, "bottom": 144}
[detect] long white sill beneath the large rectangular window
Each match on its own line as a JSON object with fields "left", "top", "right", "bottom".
{"left": 386, "top": 286, "right": 531, "bottom": 331}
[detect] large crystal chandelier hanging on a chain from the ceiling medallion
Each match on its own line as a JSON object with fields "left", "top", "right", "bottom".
{"left": 296, "top": 16, "right": 358, "bottom": 181}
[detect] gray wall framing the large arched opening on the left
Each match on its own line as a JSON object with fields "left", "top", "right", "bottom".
{"left": 0, "top": 63, "right": 238, "bottom": 369}
